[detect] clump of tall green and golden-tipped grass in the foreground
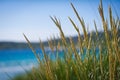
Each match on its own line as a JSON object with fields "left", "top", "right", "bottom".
{"left": 14, "top": 0, "right": 120, "bottom": 80}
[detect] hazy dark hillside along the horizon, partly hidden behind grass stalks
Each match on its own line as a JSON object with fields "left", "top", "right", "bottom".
{"left": 0, "top": 29, "right": 120, "bottom": 49}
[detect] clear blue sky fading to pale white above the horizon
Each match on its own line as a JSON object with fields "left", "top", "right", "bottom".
{"left": 0, "top": 0, "right": 120, "bottom": 42}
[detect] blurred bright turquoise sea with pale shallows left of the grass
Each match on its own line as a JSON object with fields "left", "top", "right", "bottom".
{"left": 0, "top": 49, "right": 64, "bottom": 80}
